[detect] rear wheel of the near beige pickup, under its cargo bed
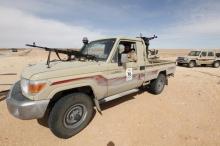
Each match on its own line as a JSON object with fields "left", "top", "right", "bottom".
{"left": 150, "top": 74, "right": 167, "bottom": 95}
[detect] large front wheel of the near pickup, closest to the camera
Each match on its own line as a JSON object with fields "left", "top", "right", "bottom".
{"left": 48, "top": 93, "right": 94, "bottom": 139}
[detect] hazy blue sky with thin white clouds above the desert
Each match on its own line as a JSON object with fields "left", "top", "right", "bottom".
{"left": 0, "top": 0, "right": 220, "bottom": 48}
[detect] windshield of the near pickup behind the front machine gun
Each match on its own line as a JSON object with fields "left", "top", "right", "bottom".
{"left": 81, "top": 39, "right": 116, "bottom": 61}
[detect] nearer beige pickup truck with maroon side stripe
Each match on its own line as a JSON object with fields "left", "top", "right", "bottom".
{"left": 6, "top": 37, "right": 176, "bottom": 138}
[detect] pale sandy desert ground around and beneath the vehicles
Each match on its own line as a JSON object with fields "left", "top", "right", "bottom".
{"left": 0, "top": 50, "right": 220, "bottom": 146}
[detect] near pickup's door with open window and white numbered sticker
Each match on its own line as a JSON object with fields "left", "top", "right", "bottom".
{"left": 108, "top": 40, "right": 145, "bottom": 96}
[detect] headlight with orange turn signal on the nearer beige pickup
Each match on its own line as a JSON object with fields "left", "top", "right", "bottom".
{"left": 21, "top": 79, "right": 47, "bottom": 96}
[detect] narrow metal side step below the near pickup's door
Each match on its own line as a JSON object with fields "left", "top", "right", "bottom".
{"left": 99, "top": 89, "right": 139, "bottom": 104}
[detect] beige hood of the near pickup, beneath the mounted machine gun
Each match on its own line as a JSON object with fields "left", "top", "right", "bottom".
{"left": 21, "top": 61, "right": 105, "bottom": 80}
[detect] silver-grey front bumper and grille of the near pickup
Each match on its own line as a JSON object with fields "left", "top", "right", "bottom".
{"left": 6, "top": 81, "right": 49, "bottom": 120}
